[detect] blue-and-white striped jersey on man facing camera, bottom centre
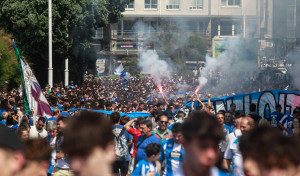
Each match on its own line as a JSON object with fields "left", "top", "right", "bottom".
{"left": 159, "top": 139, "right": 184, "bottom": 176}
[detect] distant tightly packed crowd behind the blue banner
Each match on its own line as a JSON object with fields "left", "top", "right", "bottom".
{"left": 37, "top": 74, "right": 296, "bottom": 113}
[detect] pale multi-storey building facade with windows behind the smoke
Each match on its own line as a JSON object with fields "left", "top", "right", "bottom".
{"left": 93, "top": 0, "right": 299, "bottom": 72}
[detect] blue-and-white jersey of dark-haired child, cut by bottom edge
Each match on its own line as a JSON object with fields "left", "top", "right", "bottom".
{"left": 131, "top": 160, "right": 159, "bottom": 176}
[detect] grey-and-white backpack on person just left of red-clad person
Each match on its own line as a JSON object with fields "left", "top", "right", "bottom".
{"left": 112, "top": 128, "right": 128, "bottom": 161}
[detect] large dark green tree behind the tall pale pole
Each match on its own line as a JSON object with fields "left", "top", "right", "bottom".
{"left": 0, "top": 0, "right": 127, "bottom": 85}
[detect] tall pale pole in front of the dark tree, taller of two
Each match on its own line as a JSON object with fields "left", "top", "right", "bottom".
{"left": 48, "top": 0, "right": 53, "bottom": 88}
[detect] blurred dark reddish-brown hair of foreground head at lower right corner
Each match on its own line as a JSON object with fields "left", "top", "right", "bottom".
{"left": 239, "top": 127, "right": 300, "bottom": 169}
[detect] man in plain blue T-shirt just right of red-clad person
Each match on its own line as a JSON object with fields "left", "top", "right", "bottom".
{"left": 136, "top": 120, "right": 160, "bottom": 163}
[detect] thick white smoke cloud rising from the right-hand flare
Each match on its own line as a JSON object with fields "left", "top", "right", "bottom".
{"left": 199, "top": 37, "right": 259, "bottom": 93}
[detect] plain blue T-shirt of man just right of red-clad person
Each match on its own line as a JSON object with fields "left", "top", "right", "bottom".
{"left": 136, "top": 135, "right": 160, "bottom": 162}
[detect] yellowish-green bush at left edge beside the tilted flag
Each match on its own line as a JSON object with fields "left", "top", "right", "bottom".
{"left": 0, "top": 30, "right": 21, "bottom": 88}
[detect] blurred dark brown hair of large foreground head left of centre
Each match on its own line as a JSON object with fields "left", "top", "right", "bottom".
{"left": 61, "top": 110, "right": 114, "bottom": 157}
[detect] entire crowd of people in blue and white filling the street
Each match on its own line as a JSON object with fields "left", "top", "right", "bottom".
{"left": 0, "top": 73, "right": 300, "bottom": 176}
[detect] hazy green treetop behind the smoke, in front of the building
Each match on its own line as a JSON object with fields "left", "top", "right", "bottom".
{"left": 147, "top": 22, "right": 209, "bottom": 65}
